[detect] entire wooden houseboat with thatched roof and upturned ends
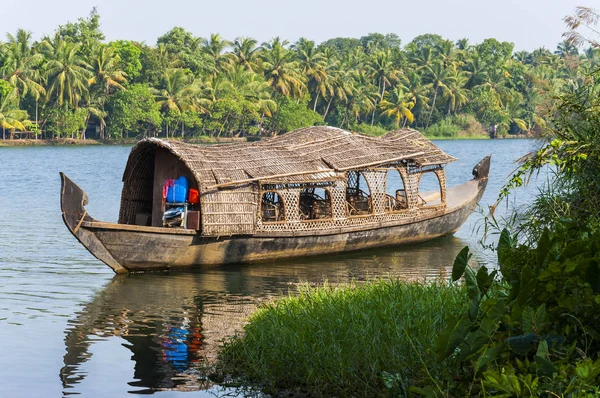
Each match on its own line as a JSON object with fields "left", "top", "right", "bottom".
{"left": 61, "top": 126, "right": 490, "bottom": 274}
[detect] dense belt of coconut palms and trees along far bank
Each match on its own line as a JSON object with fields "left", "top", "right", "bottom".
{"left": 0, "top": 10, "right": 600, "bottom": 138}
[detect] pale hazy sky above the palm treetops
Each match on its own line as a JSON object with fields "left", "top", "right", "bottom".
{"left": 0, "top": 0, "right": 600, "bottom": 51}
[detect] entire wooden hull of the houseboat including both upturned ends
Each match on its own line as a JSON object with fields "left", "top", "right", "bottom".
{"left": 61, "top": 158, "right": 489, "bottom": 273}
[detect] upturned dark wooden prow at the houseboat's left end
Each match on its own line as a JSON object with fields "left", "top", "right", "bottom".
{"left": 60, "top": 172, "right": 128, "bottom": 274}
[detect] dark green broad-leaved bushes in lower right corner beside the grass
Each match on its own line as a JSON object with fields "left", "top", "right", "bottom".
{"left": 436, "top": 221, "right": 600, "bottom": 397}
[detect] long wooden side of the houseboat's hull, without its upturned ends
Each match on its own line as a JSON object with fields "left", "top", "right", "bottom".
{"left": 94, "top": 195, "right": 477, "bottom": 272}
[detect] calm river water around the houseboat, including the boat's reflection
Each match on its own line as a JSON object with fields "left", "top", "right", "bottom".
{"left": 0, "top": 140, "right": 535, "bottom": 397}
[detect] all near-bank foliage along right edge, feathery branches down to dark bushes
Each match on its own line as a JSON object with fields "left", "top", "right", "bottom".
{"left": 421, "top": 29, "right": 600, "bottom": 397}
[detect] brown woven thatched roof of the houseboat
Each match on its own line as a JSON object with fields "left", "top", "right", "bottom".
{"left": 123, "top": 126, "right": 456, "bottom": 192}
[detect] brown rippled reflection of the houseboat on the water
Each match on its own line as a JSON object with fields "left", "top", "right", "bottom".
{"left": 60, "top": 237, "right": 480, "bottom": 394}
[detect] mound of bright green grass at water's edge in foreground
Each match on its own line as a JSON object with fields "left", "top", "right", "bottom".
{"left": 220, "top": 280, "right": 466, "bottom": 396}
